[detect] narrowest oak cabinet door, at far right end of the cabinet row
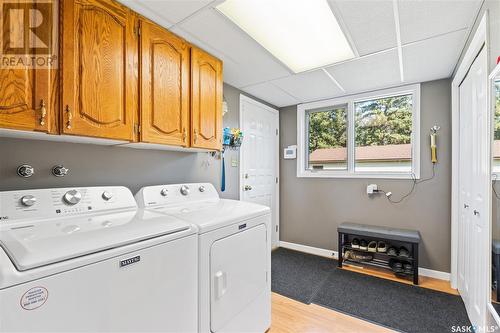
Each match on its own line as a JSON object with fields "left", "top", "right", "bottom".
{"left": 191, "top": 47, "right": 222, "bottom": 150}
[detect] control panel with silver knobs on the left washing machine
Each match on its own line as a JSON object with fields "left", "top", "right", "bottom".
{"left": 0, "top": 186, "right": 137, "bottom": 224}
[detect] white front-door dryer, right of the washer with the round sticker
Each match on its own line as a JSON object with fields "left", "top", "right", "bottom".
{"left": 136, "top": 183, "right": 271, "bottom": 333}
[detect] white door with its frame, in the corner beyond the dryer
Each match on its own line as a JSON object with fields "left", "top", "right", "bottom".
{"left": 240, "top": 95, "right": 279, "bottom": 248}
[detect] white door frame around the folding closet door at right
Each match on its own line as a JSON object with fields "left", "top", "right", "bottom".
{"left": 450, "top": 11, "right": 492, "bottom": 325}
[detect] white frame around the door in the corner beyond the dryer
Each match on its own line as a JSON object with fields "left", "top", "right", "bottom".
{"left": 238, "top": 94, "right": 281, "bottom": 248}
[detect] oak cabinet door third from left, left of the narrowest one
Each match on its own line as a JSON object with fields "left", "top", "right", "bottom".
{"left": 140, "top": 21, "right": 190, "bottom": 146}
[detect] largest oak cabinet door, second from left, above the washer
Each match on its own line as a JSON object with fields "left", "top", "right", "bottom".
{"left": 61, "top": 0, "right": 138, "bottom": 140}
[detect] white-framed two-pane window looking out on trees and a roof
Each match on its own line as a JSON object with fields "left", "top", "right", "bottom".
{"left": 297, "top": 85, "right": 420, "bottom": 178}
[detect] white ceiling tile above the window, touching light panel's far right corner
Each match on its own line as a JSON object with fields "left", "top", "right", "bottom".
{"left": 326, "top": 50, "right": 401, "bottom": 93}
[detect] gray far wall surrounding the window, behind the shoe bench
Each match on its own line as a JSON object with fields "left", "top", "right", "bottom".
{"left": 280, "top": 80, "right": 451, "bottom": 272}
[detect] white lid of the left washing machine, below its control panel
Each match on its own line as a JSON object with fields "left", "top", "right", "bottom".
{"left": 0, "top": 209, "right": 191, "bottom": 271}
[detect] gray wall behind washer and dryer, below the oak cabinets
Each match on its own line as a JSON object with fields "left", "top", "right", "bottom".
{"left": 0, "top": 84, "right": 254, "bottom": 198}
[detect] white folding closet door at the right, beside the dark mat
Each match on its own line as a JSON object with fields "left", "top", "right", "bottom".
{"left": 457, "top": 48, "right": 491, "bottom": 325}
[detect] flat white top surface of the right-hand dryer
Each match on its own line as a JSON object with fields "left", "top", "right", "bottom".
{"left": 151, "top": 198, "right": 271, "bottom": 233}
